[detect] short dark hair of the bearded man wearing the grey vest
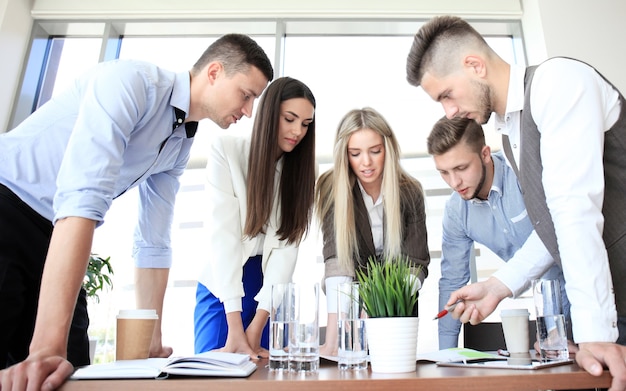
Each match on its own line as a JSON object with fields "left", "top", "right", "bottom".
{"left": 406, "top": 15, "right": 489, "bottom": 87}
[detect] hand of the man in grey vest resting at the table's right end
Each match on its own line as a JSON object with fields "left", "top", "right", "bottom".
{"left": 576, "top": 342, "right": 626, "bottom": 391}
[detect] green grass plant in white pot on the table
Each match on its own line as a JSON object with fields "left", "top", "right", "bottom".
{"left": 356, "top": 257, "right": 421, "bottom": 373}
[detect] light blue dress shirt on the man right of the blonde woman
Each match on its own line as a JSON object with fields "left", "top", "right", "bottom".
{"left": 439, "top": 152, "right": 569, "bottom": 349}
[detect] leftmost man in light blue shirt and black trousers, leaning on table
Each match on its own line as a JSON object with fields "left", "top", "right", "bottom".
{"left": 0, "top": 34, "right": 273, "bottom": 389}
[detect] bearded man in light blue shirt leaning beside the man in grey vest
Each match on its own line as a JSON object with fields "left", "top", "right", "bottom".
{"left": 427, "top": 117, "right": 569, "bottom": 349}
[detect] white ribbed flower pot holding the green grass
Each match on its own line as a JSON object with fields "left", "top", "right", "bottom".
{"left": 365, "top": 317, "right": 419, "bottom": 373}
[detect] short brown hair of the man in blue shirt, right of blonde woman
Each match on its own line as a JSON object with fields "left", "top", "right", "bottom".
{"left": 426, "top": 117, "right": 486, "bottom": 155}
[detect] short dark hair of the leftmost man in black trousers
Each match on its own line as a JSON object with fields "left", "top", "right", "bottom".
{"left": 191, "top": 34, "right": 274, "bottom": 81}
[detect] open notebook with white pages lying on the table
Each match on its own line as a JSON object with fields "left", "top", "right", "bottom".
{"left": 70, "top": 352, "right": 257, "bottom": 380}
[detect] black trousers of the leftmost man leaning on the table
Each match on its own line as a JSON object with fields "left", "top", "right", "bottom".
{"left": 0, "top": 184, "right": 89, "bottom": 369}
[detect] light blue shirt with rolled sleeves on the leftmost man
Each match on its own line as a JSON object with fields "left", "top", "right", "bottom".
{"left": 0, "top": 60, "right": 197, "bottom": 267}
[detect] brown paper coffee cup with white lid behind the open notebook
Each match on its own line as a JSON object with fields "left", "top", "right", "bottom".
{"left": 115, "top": 310, "right": 159, "bottom": 360}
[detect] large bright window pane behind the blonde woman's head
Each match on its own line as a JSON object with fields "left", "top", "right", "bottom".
{"left": 285, "top": 36, "right": 513, "bottom": 162}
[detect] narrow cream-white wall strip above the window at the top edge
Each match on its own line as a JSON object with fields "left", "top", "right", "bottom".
{"left": 28, "top": 0, "right": 521, "bottom": 19}
